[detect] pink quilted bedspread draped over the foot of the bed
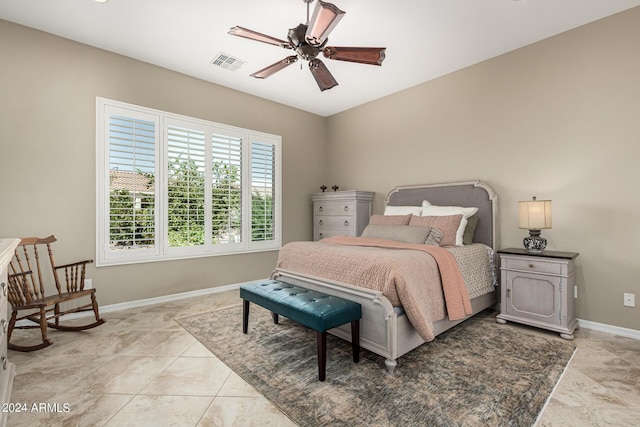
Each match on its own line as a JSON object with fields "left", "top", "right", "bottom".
{"left": 277, "top": 236, "right": 471, "bottom": 341}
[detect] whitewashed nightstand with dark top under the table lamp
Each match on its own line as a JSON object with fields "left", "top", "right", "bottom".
{"left": 496, "top": 248, "right": 579, "bottom": 340}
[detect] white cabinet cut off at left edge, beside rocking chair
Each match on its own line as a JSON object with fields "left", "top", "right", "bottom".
{"left": 0, "top": 239, "right": 20, "bottom": 426}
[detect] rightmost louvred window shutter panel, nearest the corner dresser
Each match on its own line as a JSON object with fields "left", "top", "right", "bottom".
{"left": 251, "top": 142, "right": 275, "bottom": 242}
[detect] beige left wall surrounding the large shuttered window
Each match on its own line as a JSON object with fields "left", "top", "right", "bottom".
{"left": 0, "top": 20, "right": 326, "bottom": 305}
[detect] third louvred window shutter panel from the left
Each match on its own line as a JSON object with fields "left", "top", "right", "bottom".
{"left": 211, "top": 133, "right": 243, "bottom": 245}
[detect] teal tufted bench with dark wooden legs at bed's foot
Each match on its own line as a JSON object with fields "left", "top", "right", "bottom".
{"left": 240, "top": 280, "right": 362, "bottom": 381}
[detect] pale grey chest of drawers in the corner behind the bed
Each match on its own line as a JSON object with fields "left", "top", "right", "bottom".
{"left": 311, "top": 190, "right": 375, "bottom": 240}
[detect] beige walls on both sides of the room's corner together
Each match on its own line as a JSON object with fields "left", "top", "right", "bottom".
{"left": 0, "top": 8, "right": 640, "bottom": 330}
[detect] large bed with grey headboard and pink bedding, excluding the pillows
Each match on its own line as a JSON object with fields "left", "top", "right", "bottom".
{"left": 271, "top": 181, "right": 498, "bottom": 373}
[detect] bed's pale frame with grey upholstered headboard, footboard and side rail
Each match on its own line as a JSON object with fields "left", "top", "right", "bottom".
{"left": 271, "top": 181, "right": 498, "bottom": 373}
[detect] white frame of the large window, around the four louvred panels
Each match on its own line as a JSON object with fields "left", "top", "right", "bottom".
{"left": 96, "top": 97, "right": 282, "bottom": 267}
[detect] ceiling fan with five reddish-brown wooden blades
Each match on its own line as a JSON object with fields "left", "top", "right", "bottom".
{"left": 229, "top": 0, "right": 386, "bottom": 91}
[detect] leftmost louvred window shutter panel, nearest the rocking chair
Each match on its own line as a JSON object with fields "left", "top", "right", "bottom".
{"left": 108, "top": 114, "right": 157, "bottom": 251}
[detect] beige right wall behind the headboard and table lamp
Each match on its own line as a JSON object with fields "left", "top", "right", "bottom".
{"left": 328, "top": 8, "right": 640, "bottom": 330}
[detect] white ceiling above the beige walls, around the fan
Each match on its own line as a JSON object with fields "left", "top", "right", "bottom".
{"left": 0, "top": 0, "right": 640, "bottom": 116}
